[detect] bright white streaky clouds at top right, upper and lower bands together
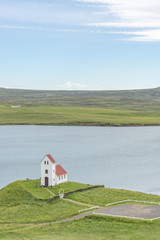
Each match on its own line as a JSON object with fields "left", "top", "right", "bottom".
{"left": 77, "top": 0, "right": 160, "bottom": 41}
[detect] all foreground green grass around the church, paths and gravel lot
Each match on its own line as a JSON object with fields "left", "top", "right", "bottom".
{"left": 0, "top": 180, "right": 160, "bottom": 240}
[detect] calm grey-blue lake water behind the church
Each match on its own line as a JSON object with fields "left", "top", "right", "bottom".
{"left": 0, "top": 126, "right": 160, "bottom": 194}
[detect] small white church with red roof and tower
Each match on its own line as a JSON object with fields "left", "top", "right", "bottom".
{"left": 41, "top": 154, "right": 67, "bottom": 186}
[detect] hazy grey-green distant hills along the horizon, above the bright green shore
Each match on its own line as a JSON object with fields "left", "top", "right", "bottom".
{"left": 0, "top": 88, "right": 160, "bottom": 107}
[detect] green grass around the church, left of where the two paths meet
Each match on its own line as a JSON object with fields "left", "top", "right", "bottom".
{"left": 0, "top": 179, "right": 88, "bottom": 223}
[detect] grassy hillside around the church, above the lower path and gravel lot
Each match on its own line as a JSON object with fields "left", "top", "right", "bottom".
{"left": 0, "top": 179, "right": 160, "bottom": 222}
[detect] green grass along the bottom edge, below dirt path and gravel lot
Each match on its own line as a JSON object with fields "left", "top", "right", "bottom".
{"left": 0, "top": 216, "right": 160, "bottom": 240}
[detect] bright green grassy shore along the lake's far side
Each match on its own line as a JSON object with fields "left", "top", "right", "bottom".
{"left": 0, "top": 105, "right": 160, "bottom": 126}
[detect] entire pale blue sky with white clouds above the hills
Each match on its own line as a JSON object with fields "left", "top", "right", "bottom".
{"left": 0, "top": 0, "right": 160, "bottom": 90}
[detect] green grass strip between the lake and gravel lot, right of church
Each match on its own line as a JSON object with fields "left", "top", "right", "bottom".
{"left": 67, "top": 188, "right": 160, "bottom": 206}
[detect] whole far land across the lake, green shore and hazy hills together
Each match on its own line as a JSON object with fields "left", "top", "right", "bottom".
{"left": 0, "top": 88, "right": 160, "bottom": 126}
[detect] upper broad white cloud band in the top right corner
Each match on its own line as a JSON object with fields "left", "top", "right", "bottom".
{"left": 77, "top": 0, "right": 160, "bottom": 27}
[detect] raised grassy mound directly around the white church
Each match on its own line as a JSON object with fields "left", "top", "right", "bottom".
{"left": 0, "top": 179, "right": 92, "bottom": 206}
